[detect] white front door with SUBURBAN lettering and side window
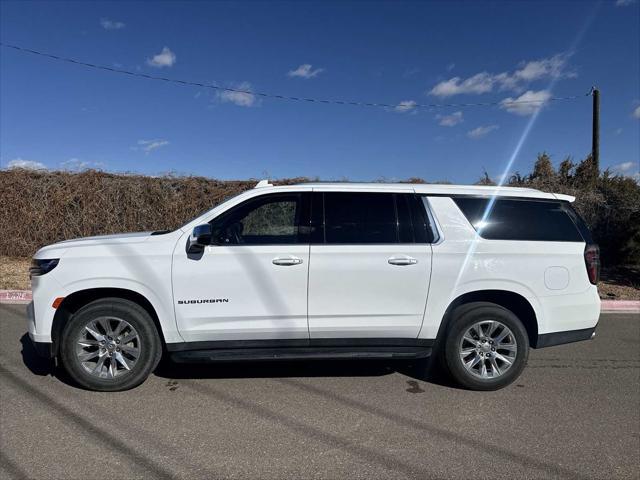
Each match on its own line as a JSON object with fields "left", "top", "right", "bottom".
{"left": 173, "top": 193, "right": 310, "bottom": 342}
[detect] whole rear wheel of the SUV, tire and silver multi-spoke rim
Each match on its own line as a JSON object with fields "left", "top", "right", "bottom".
{"left": 444, "top": 302, "right": 529, "bottom": 390}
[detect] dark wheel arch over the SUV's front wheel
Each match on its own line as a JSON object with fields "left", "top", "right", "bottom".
{"left": 51, "top": 287, "right": 166, "bottom": 356}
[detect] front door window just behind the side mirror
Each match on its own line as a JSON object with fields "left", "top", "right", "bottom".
{"left": 212, "top": 194, "right": 301, "bottom": 245}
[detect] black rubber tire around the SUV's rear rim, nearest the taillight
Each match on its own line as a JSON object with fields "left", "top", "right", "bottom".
{"left": 441, "top": 302, "right": 529, "bottom": 390}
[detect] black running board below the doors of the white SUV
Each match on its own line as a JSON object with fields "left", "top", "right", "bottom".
{"left": 171, "top": 347, "right": 431, "bottom": 363}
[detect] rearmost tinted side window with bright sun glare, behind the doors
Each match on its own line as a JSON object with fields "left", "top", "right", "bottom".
{"left": 453, "top": 197, "right": 584, "bottom": 242}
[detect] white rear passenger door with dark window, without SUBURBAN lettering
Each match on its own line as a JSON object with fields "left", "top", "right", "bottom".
{"left": 309, "top": 192, "right": 431, "bottom": 339}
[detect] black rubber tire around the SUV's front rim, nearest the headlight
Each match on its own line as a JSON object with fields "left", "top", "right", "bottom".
{"left": 60, "top": 298, "right": 162, "bottom": 392}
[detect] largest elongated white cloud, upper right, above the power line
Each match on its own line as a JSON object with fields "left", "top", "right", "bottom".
{"left": 428, "top": 54, "right": 576, "bottom": 97}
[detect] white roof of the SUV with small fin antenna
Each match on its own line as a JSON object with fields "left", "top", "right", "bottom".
{"left": 250, "top": 180, "right": 575, "bottom": 202}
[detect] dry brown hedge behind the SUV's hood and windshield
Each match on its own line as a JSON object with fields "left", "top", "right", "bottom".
{"left": 0, "top": 169, "right": 305, "bottom": 256}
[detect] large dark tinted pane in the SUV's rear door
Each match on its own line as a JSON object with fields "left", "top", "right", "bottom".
{"left": 324, "top": 192, "right": 398, "bottom": 244}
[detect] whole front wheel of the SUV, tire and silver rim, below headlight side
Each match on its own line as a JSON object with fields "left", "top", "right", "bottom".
{"left": 60, "top": 298, "right": 162, "bottom": 391}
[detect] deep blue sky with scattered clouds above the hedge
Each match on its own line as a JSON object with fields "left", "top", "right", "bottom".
{"left": 0, "top": 0, "right": 640, "bottom": 183}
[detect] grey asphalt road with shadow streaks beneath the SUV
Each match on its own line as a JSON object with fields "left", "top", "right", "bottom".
{"left": 0, "top": 305, "right": 640, "bottom": 479}
